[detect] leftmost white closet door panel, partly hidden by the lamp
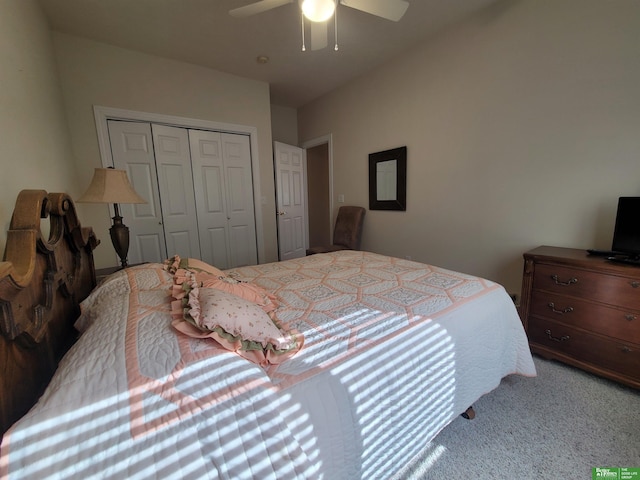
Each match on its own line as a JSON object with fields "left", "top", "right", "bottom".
{"left": 108, "top": 120, "right": 167, "bottom": 264}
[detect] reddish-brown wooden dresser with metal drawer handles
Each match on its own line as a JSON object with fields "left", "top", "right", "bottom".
{"left": 520, "top": 246, "right": 640, "bottom": 388}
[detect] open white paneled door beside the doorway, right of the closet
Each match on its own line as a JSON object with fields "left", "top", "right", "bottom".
{"left": 273, "top": 142, "right": 307, "bottom": 260}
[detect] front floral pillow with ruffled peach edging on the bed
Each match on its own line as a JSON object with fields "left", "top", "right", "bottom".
{"left": 172, "top": 272, "right": 304, "bottom": 366}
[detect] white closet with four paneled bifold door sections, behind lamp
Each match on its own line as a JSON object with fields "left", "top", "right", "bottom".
{"left": 108, "top": 120, "right": 257, "bottom": 269}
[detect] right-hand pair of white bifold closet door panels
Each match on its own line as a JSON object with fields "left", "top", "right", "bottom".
{"left": 189, "top": 130, "right": 258, "bottom": 269}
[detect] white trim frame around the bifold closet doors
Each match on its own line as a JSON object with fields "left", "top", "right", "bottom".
{"left": 93, "top": 105, "right": 265, "bottom": 263}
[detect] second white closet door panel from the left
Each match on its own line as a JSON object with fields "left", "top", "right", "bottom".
{"left": 151, "top": 124, "right": 200, "bottom": 258}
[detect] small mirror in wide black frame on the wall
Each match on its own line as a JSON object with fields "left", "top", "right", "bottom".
{"left": 369, "top": 147, "right": 407, "bottom": 211}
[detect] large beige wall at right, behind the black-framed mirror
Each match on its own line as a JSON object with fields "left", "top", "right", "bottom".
{"left": 298, "top": 0, "right": 640, "bottom": 293}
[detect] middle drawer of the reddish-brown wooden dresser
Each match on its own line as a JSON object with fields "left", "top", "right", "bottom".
{"left": 530, "top": 290, "right": 640, "bottom": 344}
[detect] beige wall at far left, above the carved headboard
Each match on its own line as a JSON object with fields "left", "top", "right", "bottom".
{"left": 0, "top": 0, "right": 78, "bottom": 252}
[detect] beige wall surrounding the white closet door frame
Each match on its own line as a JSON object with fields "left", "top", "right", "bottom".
{"left": 53, "top": 32, "right": 278, "bottom": 268}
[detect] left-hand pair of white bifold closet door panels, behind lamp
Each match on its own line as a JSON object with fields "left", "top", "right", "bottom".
{"left": 108, "top": 120, "right": 200, "bottom": 264}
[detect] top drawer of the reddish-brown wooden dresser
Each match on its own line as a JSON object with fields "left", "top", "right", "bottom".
{"left": 533, "top": 264, "right": 640, "bottom": 311}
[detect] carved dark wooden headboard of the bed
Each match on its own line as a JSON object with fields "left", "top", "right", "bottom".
{"left": 0, "top": 190, "right": 99, "bottom": 434}
